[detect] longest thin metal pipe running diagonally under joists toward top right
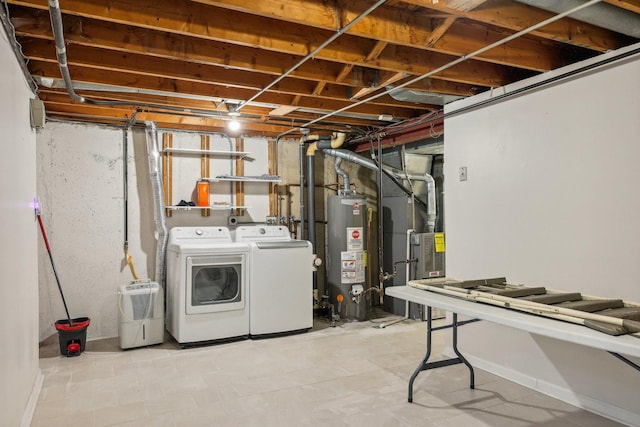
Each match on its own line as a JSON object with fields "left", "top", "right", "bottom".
{"left": 303, "top": 0, "right": 602, "bottom": 126}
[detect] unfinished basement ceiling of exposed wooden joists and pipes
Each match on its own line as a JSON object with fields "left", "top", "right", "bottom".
{"left": 2, "top": 0, "right": 640, "bottom": 137}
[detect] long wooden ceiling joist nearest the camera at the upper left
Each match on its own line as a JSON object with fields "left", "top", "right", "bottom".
{"left": 12, "top": 0, "right": 530, "bottom": 87}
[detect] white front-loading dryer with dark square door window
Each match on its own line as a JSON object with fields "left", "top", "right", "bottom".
{"left": 166, "top": 227, "right": 249, "bottom": 347}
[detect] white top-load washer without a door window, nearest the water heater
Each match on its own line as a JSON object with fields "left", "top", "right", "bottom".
{"left": 234, "top": 225, "right": 315, "bottom": 337}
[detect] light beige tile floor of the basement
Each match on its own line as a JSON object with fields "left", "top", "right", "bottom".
{"left": 32, "top": 319, "right": 619, "bottom": 427}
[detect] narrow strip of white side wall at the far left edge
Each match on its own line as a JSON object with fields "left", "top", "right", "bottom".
{"left": 0, "top": 30, "right": 39, "bottom": 426}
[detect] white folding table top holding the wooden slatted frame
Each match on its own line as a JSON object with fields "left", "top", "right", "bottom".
{"left": 384, "top": 286, "right": 640, "bottom": 357}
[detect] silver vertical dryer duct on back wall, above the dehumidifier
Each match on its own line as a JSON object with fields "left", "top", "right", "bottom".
{"left": 145, "top": 122, "right": 167, "bottom": 288}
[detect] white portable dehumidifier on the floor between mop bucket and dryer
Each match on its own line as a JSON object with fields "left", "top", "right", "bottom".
{"left": 118, "top": 280, "right": 164, "bottom": 349}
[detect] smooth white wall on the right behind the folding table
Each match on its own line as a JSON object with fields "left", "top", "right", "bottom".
{"left": 445, "top": 45, "right": 640, "bottom": 425}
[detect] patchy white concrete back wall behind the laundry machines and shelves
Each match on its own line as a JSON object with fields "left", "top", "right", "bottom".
{"left": 37, "top": 122, "right": 269, "bottom": 340}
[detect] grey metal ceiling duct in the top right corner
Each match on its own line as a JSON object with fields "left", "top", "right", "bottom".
{"left": 517, "top": 0, "right": 640, "bottom": 38}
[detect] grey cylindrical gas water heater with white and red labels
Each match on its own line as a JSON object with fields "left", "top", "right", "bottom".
{"left": 327, "top": 194, "right": 367, "bottom": 321}
